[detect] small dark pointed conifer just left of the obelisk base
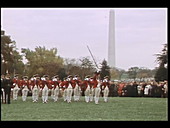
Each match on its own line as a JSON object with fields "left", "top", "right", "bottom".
{"left": 100, "top": 59, "right": 110, "bottom": 80}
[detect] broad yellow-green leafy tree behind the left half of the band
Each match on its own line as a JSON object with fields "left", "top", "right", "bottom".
{"left": 22, "top": 46, "right": 64, "bottom": 77}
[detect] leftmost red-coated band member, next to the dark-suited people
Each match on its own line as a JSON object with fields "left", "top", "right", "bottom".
{"left": 12, "top": 75, "right": 20, "bottom": 100}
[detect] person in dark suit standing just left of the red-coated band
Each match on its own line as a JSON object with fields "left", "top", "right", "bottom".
{"left": 4, "top": 74, "right": 12, "bottom": 104}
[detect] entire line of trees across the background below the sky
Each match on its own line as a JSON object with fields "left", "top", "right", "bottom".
{"left": 1, "top": 30, "right": 168, "bottom": 81}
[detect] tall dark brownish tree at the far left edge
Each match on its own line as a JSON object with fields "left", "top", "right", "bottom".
{"left": 1, "top": 30, "right": 24, "bottom": 74}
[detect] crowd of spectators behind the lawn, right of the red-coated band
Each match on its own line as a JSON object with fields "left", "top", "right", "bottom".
{"left": 113, "top": 81, "right": 168, "bottom": 97}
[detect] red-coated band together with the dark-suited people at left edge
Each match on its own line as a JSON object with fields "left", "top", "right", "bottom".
{"left": 1, "top": 71, "right": 110, "bottom": 104}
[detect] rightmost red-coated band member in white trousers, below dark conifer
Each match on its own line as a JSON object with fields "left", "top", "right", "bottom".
{"left": 102, "top": 76, "right": 110, "bottom": 102}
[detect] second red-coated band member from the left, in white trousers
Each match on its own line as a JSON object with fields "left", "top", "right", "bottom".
{"left": 21, "top": 76, "right": 30, "bottom": 101}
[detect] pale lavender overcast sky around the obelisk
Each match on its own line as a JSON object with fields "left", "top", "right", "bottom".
{"left": 1, "top": 8, "right": 167, "bottom": 70}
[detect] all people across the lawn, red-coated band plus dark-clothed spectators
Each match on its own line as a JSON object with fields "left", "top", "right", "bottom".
{"left": 1, "top": 72, "right": 168, "bottom": 104}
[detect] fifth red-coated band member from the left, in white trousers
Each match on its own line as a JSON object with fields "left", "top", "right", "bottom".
{"left": 51, "top": 75, "right": 61, "bottom": 102}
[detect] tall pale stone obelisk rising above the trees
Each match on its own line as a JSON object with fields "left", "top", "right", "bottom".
{"left": 108, "top": 10, "right": 115, "bottom": 67}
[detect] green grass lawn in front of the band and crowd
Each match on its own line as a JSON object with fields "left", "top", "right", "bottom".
{"left": 1, "top": 97, "right": 168, "bottom": 121}
